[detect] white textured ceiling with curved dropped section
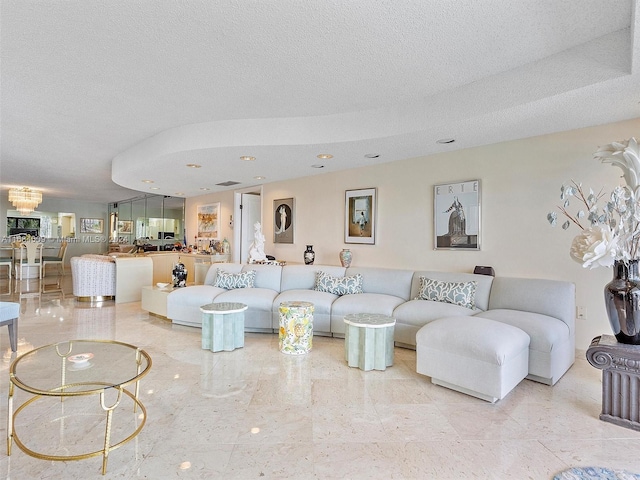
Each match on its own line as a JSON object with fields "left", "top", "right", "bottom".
{"left": 0, "top": 0, "right": 640, "bottom": 202}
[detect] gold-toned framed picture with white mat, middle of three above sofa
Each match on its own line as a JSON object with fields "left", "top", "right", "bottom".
{"left": 344, "top": 188, "right": 377, "bottom": 245}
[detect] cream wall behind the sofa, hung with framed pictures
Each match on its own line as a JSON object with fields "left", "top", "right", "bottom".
{"left": 187, "top": 119, "right": 640, "bottom": 350}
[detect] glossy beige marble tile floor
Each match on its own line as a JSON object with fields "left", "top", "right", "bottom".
{"left": 0, "top": 276, "right": 640, "bottom": 480}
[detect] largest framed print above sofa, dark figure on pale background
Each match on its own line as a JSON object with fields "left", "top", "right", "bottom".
{"left": 433, "top": 180, "right": 480, "bottom": 250}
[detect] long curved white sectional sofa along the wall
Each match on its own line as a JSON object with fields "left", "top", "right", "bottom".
{"left": 167, "top": 264, "right": 575, "bottom": 385}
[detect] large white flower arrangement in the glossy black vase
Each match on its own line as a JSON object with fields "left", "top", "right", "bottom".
{"left": 547, "top": 137, "right": 640, "bottom": 268}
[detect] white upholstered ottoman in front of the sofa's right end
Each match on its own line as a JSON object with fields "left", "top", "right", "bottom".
{"left": 416, "top": 316, "right": 530, "bottom": 403}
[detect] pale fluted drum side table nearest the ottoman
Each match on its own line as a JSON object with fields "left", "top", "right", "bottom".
{"left": 344, "top": 313, "right": 396, "bottom": 371}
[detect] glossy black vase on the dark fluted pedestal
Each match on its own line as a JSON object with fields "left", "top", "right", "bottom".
{"left": 604, "top": 260, "right": 640, "bottom": 345}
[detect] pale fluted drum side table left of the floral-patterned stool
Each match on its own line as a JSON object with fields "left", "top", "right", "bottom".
{"left": 200, "top": 302, "right": 249, "bottom": 352}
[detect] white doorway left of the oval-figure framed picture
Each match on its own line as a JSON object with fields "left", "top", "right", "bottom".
{"left": 232, "top": 187, "right": 262, "bottom": 263}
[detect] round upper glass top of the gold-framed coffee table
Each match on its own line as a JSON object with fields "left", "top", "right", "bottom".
{"left": 9, "top": 340, "right": 151, "bottom": 396}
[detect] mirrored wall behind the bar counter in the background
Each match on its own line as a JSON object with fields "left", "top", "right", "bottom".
{"left": 109, "top": 195, "right": 185, "bottom": 251}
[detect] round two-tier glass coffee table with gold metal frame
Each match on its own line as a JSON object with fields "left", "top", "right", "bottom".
{"left": 7, "top": 340, "right": 151, "bottom": 475}
